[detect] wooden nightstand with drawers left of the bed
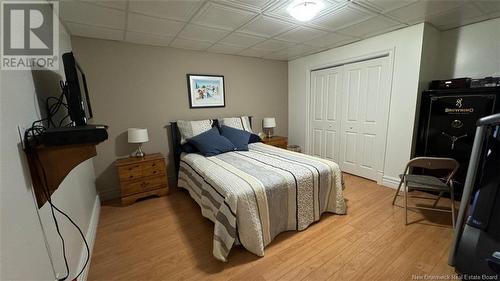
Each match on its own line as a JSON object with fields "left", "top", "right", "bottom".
{"left": 115, "top": 153, "right": 168, "bottom": 205}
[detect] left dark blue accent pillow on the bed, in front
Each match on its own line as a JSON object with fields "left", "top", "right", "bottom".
{"left": 188, "top": 127, "right": 236, "bottom": 156}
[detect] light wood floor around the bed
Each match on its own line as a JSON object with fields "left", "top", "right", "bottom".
{"left": 88, "top": 175, "right": 453, "bottom": 280}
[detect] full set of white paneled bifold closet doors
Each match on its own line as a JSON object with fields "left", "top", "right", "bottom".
{"left": 310, "top": 57, "right": 390, "bottom": 180}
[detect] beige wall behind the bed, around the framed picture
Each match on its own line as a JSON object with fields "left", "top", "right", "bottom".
{"left": 72, "top": 37, "right": 288, "bottom": 199}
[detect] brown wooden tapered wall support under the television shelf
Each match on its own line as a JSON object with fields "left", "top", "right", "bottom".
{"left": 25, "top": 143, "right": 97, "bottom": 208}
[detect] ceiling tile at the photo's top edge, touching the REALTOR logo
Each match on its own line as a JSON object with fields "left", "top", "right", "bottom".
{"left": 59, "top": 1, "right": 125, "bottom": 29}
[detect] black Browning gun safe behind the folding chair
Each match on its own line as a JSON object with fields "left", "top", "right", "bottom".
{"left": 414, "top": 87, "right": 500, "bottom": 198}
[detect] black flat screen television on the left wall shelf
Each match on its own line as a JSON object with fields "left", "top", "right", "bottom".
{"left": 62, "top": 52, "right": 92, "bottom": 126}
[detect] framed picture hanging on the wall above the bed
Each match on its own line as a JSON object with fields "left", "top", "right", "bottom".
{"left": 187, "top": 74, "right": 226, "bottom": 108}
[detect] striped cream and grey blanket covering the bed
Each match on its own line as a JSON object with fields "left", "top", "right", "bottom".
{"left": 178, "top": 143, "right": 346, "bottom": 261}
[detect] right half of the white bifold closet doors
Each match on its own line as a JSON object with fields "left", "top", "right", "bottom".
{"left": 341, "top": 58, "right": 389, "bottom": 180}
